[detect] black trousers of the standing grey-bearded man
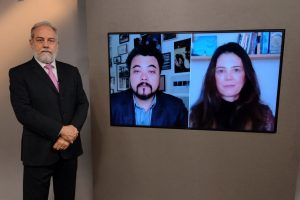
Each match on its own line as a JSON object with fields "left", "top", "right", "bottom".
{"left": 23, "top": 158, "right": 77, "bottom": 200}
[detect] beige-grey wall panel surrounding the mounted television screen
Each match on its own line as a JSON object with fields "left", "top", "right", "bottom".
{"left": 87, "top": 0, "right": 300, "bottom": 200}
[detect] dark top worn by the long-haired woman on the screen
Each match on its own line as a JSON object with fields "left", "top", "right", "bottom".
{"left": 190, "top": 99, "right": 274, "bottom": 132}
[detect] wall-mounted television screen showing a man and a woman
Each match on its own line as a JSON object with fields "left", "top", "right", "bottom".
{"left": 108, "top": 29, "right": 285, "bottom": 133}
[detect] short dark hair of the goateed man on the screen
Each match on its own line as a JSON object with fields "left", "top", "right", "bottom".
{"left": 126, "top": 44, "right": 164, "bottom": 72}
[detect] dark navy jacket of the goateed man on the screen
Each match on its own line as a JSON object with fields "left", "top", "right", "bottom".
{"left": 110, "top": 90, "right": 188, "bottom": 128}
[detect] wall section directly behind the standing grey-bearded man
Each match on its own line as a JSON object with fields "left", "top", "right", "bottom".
{"left": 0, "top": 0, "right": 93, "bottom": 200}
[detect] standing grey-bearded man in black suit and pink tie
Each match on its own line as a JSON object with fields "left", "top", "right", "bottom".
{"left": 9, "top": 22, "right": 89, "bottom": 200}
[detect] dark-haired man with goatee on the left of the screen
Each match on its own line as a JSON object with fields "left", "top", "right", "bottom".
{"left": 111, "top": 44, "right": 188, "bottom": 128}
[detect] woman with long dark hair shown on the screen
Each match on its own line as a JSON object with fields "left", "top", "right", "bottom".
{"left": 190, "top": 42, "right": 274, "bottom": 132}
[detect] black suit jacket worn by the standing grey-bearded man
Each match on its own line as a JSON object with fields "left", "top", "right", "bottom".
{"left": 9, "top": 58, "right": 89, "bottom": 166}
